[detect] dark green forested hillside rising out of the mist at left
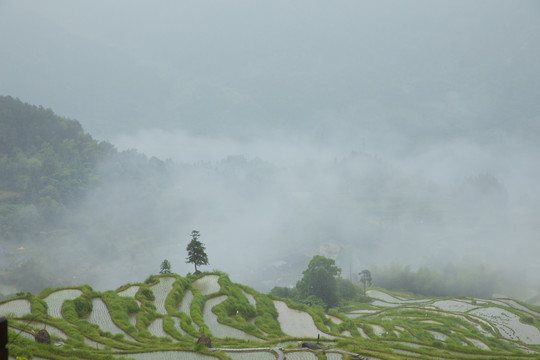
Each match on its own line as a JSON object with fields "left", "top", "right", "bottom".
{"left": 0, "top": 97, "right": 115, "bottom": 241}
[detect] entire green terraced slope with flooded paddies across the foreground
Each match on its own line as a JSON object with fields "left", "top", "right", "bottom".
{"left": 0, "top": 272, "right": 540, "bottom": 360}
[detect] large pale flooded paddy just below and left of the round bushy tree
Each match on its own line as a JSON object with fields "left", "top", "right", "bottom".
{"left": 274, "top": 301, "right": 334, "bottom": 338}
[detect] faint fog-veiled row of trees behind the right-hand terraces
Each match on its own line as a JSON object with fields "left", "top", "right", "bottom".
{"left": 372, "top": 262, "right": 497, "bottom": 298}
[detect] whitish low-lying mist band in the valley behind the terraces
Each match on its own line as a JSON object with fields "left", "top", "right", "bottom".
{"left": 35, "top": 126, "right": 540, "bottom": 298}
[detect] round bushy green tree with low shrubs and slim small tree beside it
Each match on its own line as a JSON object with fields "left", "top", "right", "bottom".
{"left": 270, "top": 255, "right": 371, "bottom": 308}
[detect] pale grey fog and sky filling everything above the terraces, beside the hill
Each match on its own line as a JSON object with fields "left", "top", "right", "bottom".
{"left": 0, "top": 1, "right": 540, "bottom": 300}
